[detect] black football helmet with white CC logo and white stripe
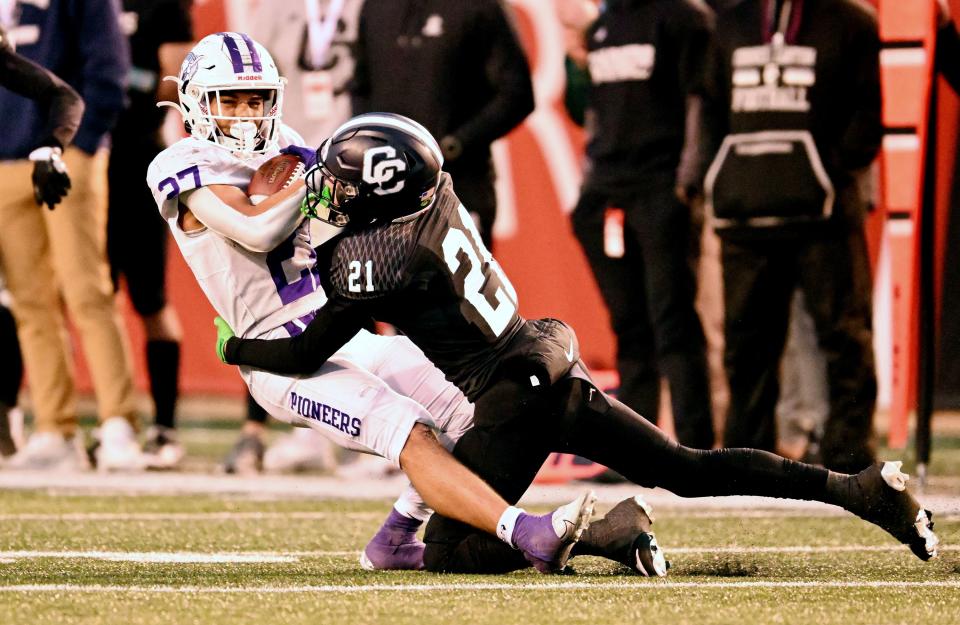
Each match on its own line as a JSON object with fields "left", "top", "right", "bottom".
{"left": 304, "top": 113, "right": 443, "bottom": 227}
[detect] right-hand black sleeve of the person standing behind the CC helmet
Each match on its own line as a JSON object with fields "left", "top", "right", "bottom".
{"left": 453, "top": 0, "right": 534, "bottom": 152}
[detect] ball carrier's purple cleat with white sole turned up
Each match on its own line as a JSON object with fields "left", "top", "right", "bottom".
{"left": 513, "top": 490, "right": 597, "bottom": 573}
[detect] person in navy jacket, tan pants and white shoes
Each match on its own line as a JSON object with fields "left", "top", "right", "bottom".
{"left": 0, "top": 0, "right": 141, "bottom": 469}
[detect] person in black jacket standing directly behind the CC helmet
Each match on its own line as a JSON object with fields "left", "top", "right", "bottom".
{"left": 350, "top": 0, "right": 534, "bottom": 247}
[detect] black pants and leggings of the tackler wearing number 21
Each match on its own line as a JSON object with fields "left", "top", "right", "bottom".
{"left": 424, "top": 367, "right": 828, "bottom": 573}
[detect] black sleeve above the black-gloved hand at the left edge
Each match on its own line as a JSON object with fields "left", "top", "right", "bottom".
{"left": 0, "top": 45, "right": 83, "bottom": 147}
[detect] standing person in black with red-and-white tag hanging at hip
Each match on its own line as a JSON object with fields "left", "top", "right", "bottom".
{"left": 556, "top": 0, "right": 714, "bottom": 449}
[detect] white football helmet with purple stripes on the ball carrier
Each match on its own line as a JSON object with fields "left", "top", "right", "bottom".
{"left": 158, "top": 32, "right": 286, "bottom": 157}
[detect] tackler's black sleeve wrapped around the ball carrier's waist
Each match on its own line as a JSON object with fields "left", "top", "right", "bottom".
{"left": 224, "top": 297, "right": 369, "bottom": 374}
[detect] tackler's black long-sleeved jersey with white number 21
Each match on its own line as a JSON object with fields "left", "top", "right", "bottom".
{"left": 226, "top": 174, "right": 540, "bottom": 399}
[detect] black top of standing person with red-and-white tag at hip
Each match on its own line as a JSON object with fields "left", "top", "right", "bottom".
{"left": 586, "top": 0, "right": 713, "bottom": 189}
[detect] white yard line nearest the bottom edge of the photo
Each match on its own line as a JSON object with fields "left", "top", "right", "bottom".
{"left": 0, "top": 580, "right": 960, "bottom": 595}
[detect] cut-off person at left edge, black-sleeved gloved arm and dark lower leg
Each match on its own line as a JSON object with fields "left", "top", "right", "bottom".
{"left": 0, "top": 22, "right": 83, "bottom": 462}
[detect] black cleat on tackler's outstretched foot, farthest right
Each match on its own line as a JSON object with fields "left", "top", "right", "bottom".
{"left": 846, "top": 461, "right": 940, "bottom": 561}
